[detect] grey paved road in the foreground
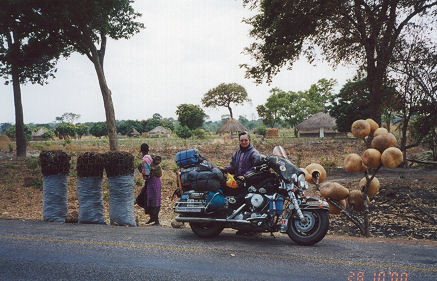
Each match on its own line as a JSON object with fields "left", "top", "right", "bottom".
{"left": 0, "top": 220, "right": 437, "bottom": 281}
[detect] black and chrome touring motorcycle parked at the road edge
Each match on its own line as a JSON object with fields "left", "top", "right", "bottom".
{"left": 174, "top": 147, "right": 329, "bottom": 245}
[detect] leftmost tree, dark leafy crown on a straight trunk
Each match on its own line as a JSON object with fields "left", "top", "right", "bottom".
{"left": 0, "top": 0, "right": 68, "bottom": 157}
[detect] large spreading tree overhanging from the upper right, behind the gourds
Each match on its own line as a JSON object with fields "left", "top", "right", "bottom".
{"left": 242, "top": 0, "right": 437, "bottom": 123}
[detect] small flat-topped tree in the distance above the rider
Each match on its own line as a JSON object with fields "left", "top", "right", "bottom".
{"left": 202, "top": 83, "right": 250, "bottom": 118}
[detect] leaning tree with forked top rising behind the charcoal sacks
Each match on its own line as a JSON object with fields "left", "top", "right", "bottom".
{"left": 42, "top": 0, "right": 144, "bottom": 150}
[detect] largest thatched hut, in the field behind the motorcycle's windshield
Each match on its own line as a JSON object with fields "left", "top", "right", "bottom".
{"left": 296, "top": 112, "right": 345, "bottom": 138}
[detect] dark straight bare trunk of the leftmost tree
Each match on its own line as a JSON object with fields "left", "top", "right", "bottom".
{"left": 12, "top": 65, "right": 26, "bottom": 157}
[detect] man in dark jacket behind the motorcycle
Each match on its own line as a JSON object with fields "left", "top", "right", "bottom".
{"left": 221, "top": 132, "right": 260, "bottom": 181}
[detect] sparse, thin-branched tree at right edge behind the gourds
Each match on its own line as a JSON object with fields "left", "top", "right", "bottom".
{"left": 389, "top": 29, "right": 437, "bottom": 162}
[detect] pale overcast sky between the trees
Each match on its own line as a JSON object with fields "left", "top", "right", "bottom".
{"left": 0, "top": 0, "right": 355, "bottom": 123}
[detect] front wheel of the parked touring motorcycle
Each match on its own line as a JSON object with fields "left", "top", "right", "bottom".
{"left": 287, "top": 210, "right": 329, "bottom": 246}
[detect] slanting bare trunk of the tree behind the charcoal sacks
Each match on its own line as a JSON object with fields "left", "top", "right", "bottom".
{"left": 93, "top": 52, "right": 118, "bottom": 151}
